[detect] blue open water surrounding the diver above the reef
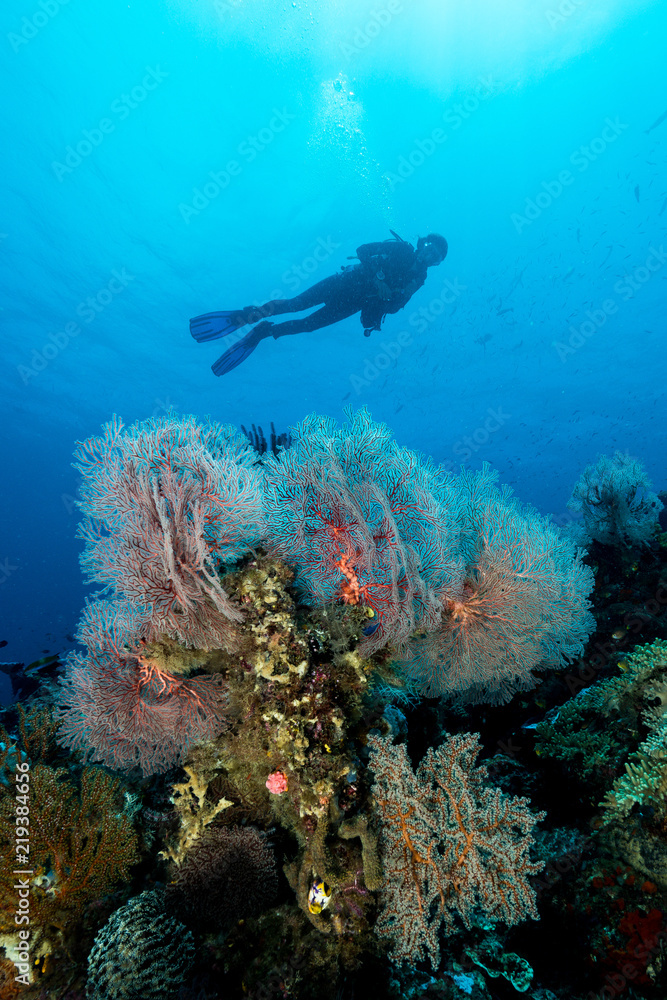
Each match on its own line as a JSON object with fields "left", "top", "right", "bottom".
{"left": 0, "top": 0, "right": 667, "bottom": 684}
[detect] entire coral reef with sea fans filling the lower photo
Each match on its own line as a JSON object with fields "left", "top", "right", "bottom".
{"left": 10, "top": 410, "right": 667, "bottom": 1000}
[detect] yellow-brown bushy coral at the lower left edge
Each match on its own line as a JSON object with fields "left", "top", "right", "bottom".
{"left": 0, "top": 710, "right": 139, "bottom": 957}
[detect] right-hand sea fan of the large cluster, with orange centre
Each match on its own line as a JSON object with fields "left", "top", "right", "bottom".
{"left": 404, "top": 465, "right": 594, "bottom": 704}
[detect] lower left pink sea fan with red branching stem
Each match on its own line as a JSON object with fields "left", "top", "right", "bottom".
{"left": 57, "top": 601, "right": 228, "bottom": 775}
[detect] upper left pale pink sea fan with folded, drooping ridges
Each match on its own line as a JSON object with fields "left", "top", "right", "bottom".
{"left": 75, "top": 415, "right": 263, "bottom": 650}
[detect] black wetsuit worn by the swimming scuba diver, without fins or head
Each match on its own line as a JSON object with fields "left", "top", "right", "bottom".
{"left": 249, "top": 240, "right": 427, "bottom": 339}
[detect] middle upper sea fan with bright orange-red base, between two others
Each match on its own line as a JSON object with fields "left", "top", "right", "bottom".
{"left": 265, "top": 409, "right": 457, "bottom": 654}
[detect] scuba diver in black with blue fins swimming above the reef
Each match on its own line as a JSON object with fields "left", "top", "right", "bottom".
{"left": 190, "top": 229, "right": 447, "bottom": 375}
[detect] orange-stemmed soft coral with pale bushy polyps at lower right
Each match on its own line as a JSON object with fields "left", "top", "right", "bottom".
{"left": 369, "top": 733, "right": 546, "bottom": 968}
